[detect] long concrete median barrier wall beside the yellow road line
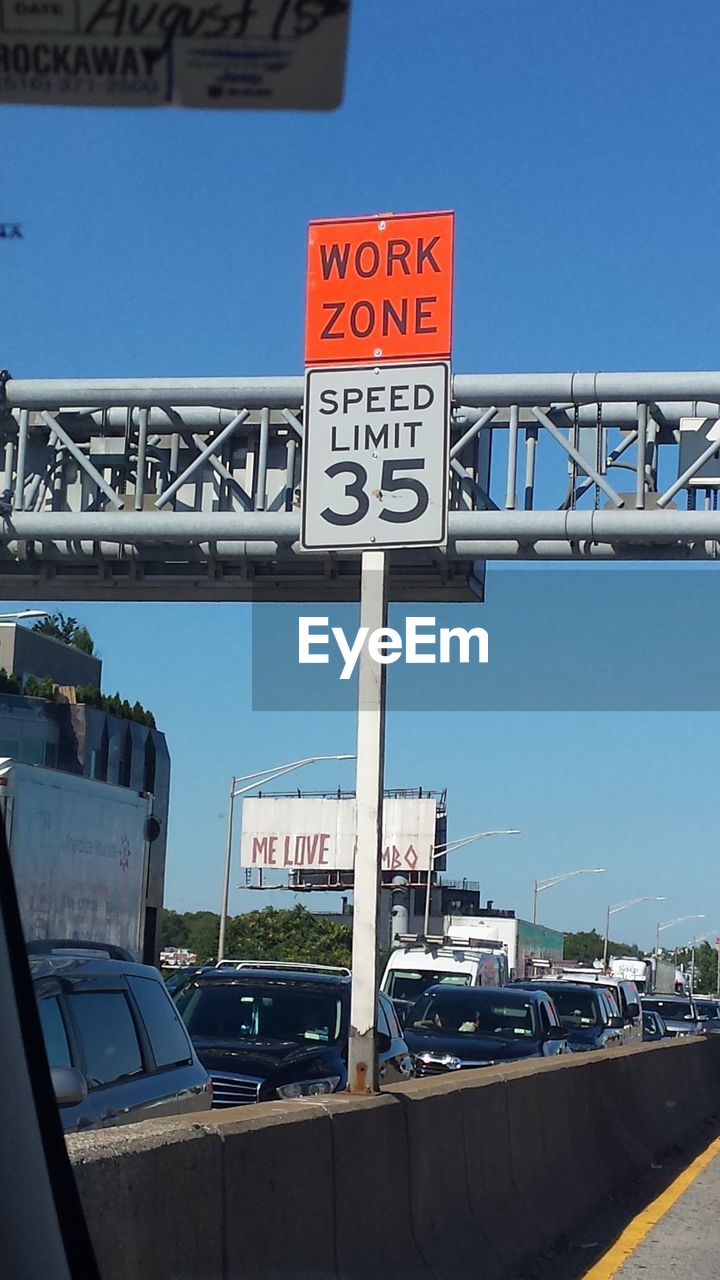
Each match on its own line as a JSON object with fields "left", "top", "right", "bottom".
{"left": 68, "top": 1037, "right": 720, "bottom": 1280}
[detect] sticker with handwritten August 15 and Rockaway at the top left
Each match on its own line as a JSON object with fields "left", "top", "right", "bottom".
{"left": 0, "top": 0, "right": 350, "bottom": 111}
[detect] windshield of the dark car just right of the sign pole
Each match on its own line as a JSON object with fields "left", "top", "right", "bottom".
{"left": 406, "top": 989, "right": 538, "bottom": 1039}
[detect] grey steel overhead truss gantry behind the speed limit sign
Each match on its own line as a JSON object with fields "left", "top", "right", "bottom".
{"left": 0, "top": 372, "right": 720, "bottom": 600}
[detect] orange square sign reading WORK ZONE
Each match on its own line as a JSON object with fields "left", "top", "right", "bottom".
{"left": 305, "top": 212, "right": 455, "bottom": 365}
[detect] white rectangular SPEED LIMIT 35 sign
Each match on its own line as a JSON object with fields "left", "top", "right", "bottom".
{"left": 301, "top": 361, "right": 450, "bottom": 550}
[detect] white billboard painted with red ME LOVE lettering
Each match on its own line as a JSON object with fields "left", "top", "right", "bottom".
{"left": 240, "top": 796, "right": 436, "bottom": 872}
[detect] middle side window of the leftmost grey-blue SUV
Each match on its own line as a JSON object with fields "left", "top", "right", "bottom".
{"left": 67, "top": 991, "right": 142, "bottom": 1088}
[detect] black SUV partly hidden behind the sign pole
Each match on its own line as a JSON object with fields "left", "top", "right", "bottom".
{"left": 170, "top": 963, "right": 413, "bottom": 1107}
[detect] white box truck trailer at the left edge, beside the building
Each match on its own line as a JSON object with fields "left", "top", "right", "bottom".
{"left": 0, "top": 756, "right": 154, "bottom": 959}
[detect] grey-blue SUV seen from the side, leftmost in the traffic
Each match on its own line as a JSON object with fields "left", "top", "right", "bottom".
{"left": 28, "top": 943, "right": 213, "bottom": 1133}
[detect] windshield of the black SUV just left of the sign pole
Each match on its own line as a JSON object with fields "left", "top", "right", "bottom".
{"left": 176, "top": 982, "right": 342, "bottom": 1044}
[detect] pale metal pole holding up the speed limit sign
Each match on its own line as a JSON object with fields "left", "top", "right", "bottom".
{"left": 347, "top": 552, "right": 387, "bottom": 1093}
